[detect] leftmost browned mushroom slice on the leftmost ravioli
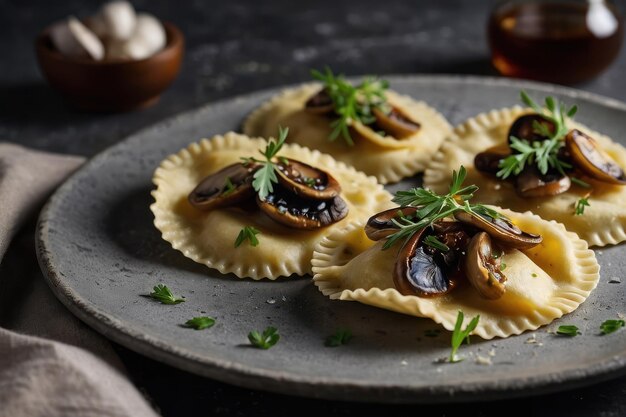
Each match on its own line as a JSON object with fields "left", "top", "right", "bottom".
{"left": 188, "top": 163, "right": 258, "bottom": 210}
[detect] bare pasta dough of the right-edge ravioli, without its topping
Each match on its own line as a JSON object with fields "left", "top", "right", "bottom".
{"left": 424, "top": 107, "right": 626, "bottom": 246}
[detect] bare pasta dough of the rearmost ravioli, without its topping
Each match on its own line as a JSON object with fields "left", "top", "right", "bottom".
{"left": 243, "top": 84, "right": 452, "bottom": 184}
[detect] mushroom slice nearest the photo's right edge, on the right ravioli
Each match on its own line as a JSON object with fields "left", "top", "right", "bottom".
{"left": 565, "top": 129, "right": 626, "bottom": 185}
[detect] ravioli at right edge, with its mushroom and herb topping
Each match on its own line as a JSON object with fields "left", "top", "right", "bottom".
{"left": 424, "top": 92, "right": 626, "bottom": 246}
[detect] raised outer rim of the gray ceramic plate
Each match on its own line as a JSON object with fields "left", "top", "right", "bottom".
{"left": 35, "top": 74, "right": 626, "bottom": 403}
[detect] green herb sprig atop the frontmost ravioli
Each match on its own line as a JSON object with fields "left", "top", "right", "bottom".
{"left": 383, "top": 166, "right": 500, "bottom": 249}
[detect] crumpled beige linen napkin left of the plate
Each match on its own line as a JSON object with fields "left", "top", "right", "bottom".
{"left": 0, "top": 143, "right": 157, "bottom": 417}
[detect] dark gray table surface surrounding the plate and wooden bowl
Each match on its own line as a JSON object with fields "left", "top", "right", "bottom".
{"left": 0, "top": 0, "right": 626, "bottom": 416}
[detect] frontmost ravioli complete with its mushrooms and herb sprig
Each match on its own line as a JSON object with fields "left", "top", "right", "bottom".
{"left": 312, "top": 171, "right": 600, "bottom": 339}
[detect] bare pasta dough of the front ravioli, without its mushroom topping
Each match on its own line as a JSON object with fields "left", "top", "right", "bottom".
{"left": 312, "top": 210, "right": 600, "bottom": 339}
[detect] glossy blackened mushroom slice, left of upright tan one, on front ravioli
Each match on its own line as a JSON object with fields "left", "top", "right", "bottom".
{"left": 393, "top": 229, "right": 456, "bottom": 297}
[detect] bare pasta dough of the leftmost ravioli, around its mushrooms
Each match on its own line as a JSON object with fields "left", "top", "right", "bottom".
{"left": 150, "top": 133, "right": 392, "bottom": 279}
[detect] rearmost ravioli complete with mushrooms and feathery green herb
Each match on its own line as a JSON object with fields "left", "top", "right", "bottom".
{"left": 243, "top": 68, "right": 452, "bottom": 184}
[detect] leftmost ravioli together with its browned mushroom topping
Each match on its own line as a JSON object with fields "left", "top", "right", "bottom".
{"left": 150, "top": 132, "right": 391, "bottom": 279}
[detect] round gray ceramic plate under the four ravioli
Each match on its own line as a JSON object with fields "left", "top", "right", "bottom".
{"left": 38, "top": 76, "right": 626, "bottom": 402}
